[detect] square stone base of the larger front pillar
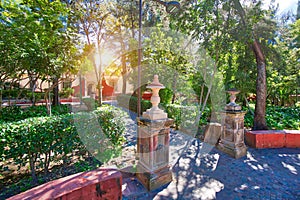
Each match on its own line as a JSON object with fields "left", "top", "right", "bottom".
{"left": 136, "top": 164, "right": 173, "bottom": 191}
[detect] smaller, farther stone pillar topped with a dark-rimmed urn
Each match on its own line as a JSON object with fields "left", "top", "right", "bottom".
{"left": 217, "top": 89, "right": 247, "bottom": 158}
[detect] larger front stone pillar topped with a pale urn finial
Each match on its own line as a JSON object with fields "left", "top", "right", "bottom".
{"left": 137, "top": 75, "right": 173, "bottom": 190}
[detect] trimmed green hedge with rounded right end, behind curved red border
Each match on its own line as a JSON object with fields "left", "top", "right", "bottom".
{"left": 0, "top": 106, "right": 125, "bottom": 182}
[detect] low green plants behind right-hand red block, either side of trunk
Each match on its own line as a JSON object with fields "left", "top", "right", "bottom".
{"left": 245, "top": 106, "right": 300, "bottom": 130}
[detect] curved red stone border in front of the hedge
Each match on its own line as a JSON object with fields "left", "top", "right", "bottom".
{"left": 8, "top": 168, "right": 122, "bottom": 200}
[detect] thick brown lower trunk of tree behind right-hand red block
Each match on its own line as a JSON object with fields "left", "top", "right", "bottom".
{"left": 253, "top": 40, "right": 268, "bottom": 130}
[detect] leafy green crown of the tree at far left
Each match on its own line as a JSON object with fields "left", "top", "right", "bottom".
{"left": 0, "top": 0, "right": 77, "bottom": 106}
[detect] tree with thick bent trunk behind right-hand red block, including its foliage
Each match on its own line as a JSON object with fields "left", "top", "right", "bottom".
{"left": 177, "top": 0, "right": 276, "bottom": 129}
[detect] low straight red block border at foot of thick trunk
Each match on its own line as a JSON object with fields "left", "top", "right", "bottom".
{"left": 245, "top": 130, "right": 300, "bottom": 149}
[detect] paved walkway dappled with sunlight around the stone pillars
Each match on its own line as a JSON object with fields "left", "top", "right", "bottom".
{"left": 112, "top": 108, "right": 300, "bottom": 200}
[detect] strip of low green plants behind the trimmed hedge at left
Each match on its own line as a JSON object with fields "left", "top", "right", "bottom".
{"left": 0, "top": 105, "right": 71, "bottom": 122}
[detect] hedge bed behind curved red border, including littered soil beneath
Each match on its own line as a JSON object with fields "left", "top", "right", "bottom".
{"left": 0, "top": 106, "right": 125, "bottom": 199}
